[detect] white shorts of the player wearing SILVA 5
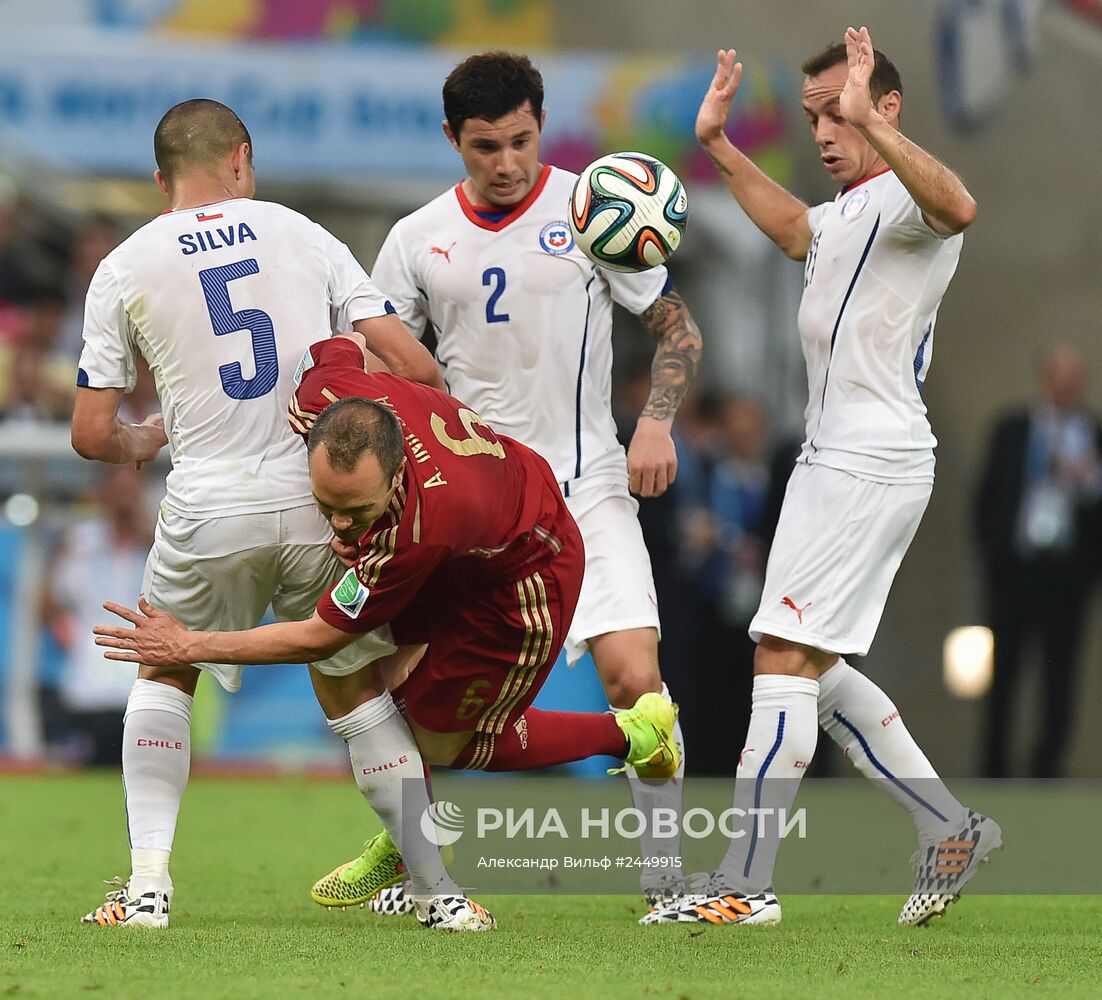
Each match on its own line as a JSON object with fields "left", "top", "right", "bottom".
{"left": 142, "top": 504, "right": 395, "bottom": 691}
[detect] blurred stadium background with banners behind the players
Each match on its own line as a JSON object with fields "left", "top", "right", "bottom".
{"left": 0, "top": 0, "right": 1102, "bottom": 777}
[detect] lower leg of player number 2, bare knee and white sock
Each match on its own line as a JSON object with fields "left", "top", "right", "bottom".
{"left": 588, "top": 628, "right": 684, "bottom": 906}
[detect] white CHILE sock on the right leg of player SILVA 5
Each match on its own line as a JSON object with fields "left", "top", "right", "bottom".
{"left": 328, "top": 691, "right": 458, "bottom": 896}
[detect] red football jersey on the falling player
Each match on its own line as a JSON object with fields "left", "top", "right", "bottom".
{"left": 289, "top": 337, "right": 577, "bottom": 641}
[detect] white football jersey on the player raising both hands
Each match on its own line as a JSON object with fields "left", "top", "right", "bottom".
{"left": 799, "top": 171, "right": 964, "bottom": 482}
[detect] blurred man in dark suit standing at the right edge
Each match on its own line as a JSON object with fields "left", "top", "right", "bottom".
{"left": 974, "top": 344, "right": 1102, "bottom": 777}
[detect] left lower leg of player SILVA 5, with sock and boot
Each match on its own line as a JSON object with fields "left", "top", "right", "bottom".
{"left": 83, "top": 666, "right": 199, "bottom": 928}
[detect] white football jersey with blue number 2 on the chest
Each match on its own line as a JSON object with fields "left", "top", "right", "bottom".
{"left": 371, "top": 166, "right": 668, "bottom": 496}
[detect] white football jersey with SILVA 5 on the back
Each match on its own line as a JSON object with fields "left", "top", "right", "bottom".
{"left": 77, "top": 198, "right": 392, "bottom": 518}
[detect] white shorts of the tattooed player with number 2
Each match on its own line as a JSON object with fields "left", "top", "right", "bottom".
{"left": 565, "top": 483, "right": 661, "bottom": 664}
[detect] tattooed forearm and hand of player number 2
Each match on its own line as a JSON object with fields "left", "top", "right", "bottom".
{"left": 627, "top": 289, "right": 701, "bottom": 496}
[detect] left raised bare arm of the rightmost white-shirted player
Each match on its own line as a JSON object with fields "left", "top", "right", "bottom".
{"left": 696, "top": 49, "right": 811, "bottom": 260}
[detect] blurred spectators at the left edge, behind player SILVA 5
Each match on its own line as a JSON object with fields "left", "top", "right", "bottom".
{"left": 0, "top": 187, "right": 161, "bottom": 764}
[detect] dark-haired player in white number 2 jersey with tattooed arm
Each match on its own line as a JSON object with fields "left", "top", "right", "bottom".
{"left": 328, "top": 52, "right": 701, "bottom": 903}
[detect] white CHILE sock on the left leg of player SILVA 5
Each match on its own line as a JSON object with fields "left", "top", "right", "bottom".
{"left": 122, "top": 678, "right": 192, "bottom": 893}
